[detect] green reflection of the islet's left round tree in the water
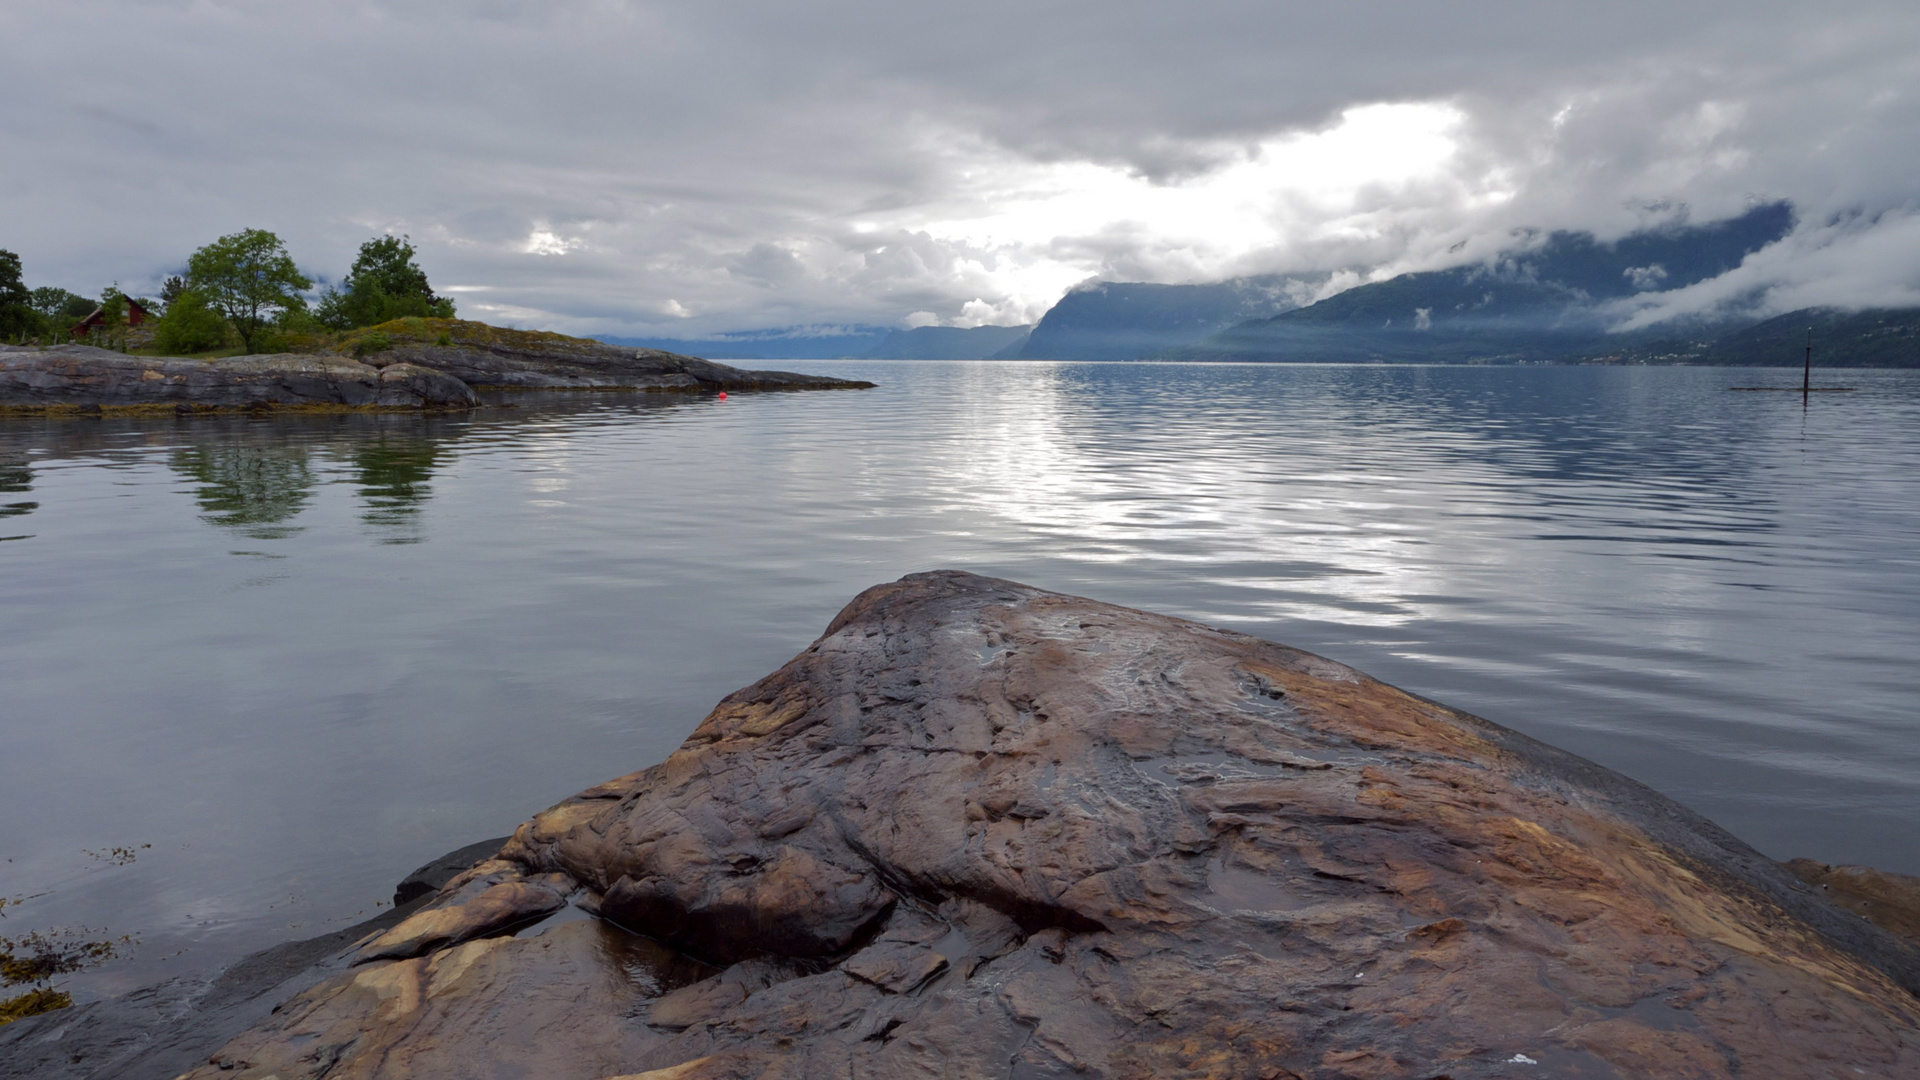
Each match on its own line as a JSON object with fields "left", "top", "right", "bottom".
{"left": 169, "top": 440, "right": 315, "bottom": 540}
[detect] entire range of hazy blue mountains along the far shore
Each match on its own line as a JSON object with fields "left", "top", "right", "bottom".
{"left": 601, "top": 202, "right": 1920, "bottom": 367}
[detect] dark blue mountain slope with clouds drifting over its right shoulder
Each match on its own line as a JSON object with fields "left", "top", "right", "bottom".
{"left": 1175, "top": 202, "right": 1793, "bottom": 363}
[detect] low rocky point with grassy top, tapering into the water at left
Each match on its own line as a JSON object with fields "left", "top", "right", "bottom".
{"left": 0, "top": 319, "right": 872, "bottom": 415}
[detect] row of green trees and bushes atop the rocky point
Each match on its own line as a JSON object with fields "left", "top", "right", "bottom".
{"left": 0, "top": 229, "right": 453, "bottom": 354}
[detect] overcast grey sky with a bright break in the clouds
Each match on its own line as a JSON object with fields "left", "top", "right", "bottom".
{"left": 0, "top": 0, "right": 1920, "bottom": 336}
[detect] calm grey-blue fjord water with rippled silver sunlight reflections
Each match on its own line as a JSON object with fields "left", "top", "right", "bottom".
{"left": 0, "top": 361, "right": 1920, "bottom": 992}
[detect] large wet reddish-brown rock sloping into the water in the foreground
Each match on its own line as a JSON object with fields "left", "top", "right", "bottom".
{"left": 176, "top": 573, "right": 1920, "bottom": 1080}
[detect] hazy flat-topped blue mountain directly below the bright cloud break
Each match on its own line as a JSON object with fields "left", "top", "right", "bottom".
{"left": 1018, "top": 277, "right": 1300, "bottom": 359}
